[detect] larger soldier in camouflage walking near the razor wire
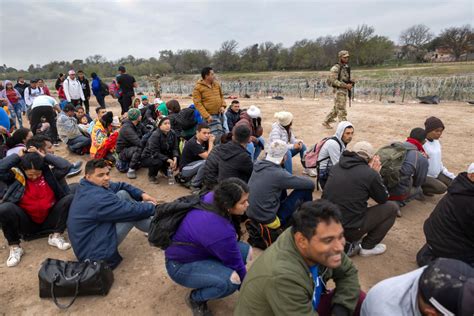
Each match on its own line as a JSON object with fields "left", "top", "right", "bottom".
{"left": 323, "top": 50, "right": 354, "bottom": 129}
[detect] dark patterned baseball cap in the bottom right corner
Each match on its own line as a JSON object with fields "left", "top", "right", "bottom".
{"left": 418, "top": 258, "right": 474, "bottom": 316}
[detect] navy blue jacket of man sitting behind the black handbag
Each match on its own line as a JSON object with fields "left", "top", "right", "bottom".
{"left": 67, "top": 179, "right": 155, "bottom": 269}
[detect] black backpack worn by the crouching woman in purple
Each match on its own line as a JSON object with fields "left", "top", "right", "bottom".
{"left": 148, "top": 195, "right": 201, "bottom": 250}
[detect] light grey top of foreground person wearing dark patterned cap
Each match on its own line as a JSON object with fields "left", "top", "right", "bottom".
{"left": 360, "top": 267, "right": 426, "bottom": 316}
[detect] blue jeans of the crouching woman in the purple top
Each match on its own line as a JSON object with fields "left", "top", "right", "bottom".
{"left": 166, "top": 241, "right": 250, "bottom": 302}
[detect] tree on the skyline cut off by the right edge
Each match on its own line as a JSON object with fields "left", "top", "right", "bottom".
{"left": 439, "top": 24, "right": 474, "bottom": 60}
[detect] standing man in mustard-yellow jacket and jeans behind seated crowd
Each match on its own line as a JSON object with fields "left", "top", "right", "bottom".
{"left": 193, "top": 67, "right": 226, "bottom": 142}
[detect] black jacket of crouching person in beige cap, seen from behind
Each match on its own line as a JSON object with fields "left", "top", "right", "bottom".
{"left": 322, "top": 150, "right": 388, "bottom": 229}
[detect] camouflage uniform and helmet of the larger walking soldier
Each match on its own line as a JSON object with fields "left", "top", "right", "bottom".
{"left": 324, "top": 51, "right": 350, "bottom": 124}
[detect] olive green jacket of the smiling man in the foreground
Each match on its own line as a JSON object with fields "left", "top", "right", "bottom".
{"left": 234, "top": 228, "right": 360, "bottom": 316}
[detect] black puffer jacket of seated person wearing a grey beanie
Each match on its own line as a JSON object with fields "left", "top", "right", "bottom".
{"left": 142, "top": 129, "right": 179, "bottom": 161}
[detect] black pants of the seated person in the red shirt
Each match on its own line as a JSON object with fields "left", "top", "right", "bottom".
{"left": 0, "top": 194, "right": 74, "bottom": 246}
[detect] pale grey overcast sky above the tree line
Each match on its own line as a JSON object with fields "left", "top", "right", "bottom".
{"left": 0, "top": 0, "right": 474, "bottom": 68}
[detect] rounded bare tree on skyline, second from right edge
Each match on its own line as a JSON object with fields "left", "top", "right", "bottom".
{"left": 400, "top": 24, "right": 434, "bottom": 61}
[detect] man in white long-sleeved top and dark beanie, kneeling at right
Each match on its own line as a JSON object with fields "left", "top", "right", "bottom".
{"left": 421, "top": 116, "right": 455, "bottom": 196}
